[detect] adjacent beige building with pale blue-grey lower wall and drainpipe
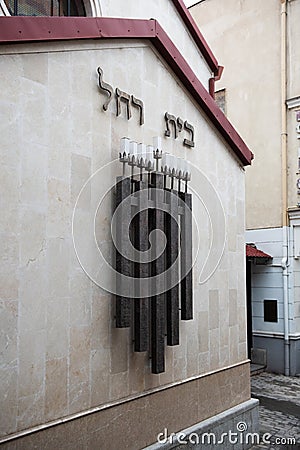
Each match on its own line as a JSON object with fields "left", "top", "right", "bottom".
{"left": 190, "top": 0, "right": 300, "bottom": 375}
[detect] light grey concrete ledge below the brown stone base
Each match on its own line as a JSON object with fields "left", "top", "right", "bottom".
{"left": 145, "top": 399, "right": 259, "bottom": 450}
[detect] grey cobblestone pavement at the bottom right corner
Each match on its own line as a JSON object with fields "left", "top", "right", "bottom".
{"left": 251, "top": 372, "right": 300, "bottom": 450}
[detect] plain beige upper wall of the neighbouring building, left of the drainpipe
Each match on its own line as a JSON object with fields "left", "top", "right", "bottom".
{"left": 190, "top": 0, "right": 282, "bottom": 229}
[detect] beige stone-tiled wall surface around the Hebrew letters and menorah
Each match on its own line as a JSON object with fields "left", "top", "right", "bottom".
{"left": 0, "top": 41, "right": 247, "bottom": 435}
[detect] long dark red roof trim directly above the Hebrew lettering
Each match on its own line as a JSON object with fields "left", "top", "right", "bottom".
{"left": 0, "top": 17, "right": 253, "bottom": 165}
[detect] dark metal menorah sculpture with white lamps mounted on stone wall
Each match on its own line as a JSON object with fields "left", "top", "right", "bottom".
{"left": 115, "top": 138, "right": 193, "bottom": 374}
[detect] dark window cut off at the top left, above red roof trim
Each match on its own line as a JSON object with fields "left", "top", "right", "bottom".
{"left": 5, "top": 0, "right": 86, "bottom": 16}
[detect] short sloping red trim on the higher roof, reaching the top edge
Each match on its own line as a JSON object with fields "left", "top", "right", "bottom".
{"left": 172, "top": 0, "right": 219, "bottom": 76}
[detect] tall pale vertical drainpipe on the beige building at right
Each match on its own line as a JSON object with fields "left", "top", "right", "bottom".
{"left": 281, "top": 0, "right": 290, "bottom": 376}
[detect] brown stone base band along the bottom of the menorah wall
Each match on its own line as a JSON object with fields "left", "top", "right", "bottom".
{"left": 0, "top": 360, "right": 255, "bottom": 450}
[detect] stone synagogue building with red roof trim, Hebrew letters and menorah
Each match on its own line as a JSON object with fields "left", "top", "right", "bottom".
{"left": 0, "top": 0, "right": 258, "bottom": 450}
